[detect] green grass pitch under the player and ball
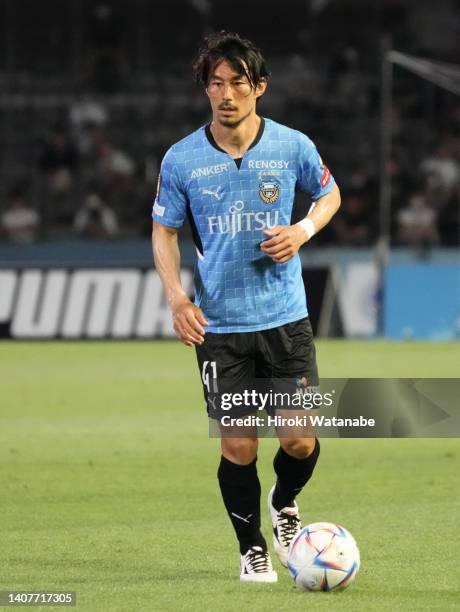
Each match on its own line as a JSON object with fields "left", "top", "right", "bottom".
{"left": 0, "top": 341, "right": 460, "bottom": 612}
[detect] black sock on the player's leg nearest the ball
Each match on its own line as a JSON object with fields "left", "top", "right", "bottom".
{"left": 272, "top": 439, "right": 320, "bottom": 512}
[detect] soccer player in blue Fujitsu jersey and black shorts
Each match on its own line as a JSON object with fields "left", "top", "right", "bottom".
{"left": 152, "top": 32, "right": 340, "bottom": 582}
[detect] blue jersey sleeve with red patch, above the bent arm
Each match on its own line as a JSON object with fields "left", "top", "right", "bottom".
{"left": 297, "top": 134, "right": 335, "bottom": 201}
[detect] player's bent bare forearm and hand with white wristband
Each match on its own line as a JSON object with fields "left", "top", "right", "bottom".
{"left": 260, "top": 184, "right": 340, "bottom": 263}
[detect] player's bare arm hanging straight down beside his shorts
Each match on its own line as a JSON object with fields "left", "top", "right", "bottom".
{"left": 152, "top": 222, "right": 208, "bottom": 346}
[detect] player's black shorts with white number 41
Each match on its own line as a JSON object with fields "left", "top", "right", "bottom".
{"left": 196, "top": 317, "right": 319, "bottom": 419}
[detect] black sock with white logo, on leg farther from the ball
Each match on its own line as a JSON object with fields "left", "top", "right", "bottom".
{"left": 217, "top": 456, "right": 267, "bottom": 555}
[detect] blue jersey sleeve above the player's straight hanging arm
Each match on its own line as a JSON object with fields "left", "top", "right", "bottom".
{"left": 152, "top": 149, "right": 187, "bottom": 228}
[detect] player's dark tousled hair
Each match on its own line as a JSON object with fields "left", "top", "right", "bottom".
{"left": 192, "top": 30, "right": 269, "bottom": 88}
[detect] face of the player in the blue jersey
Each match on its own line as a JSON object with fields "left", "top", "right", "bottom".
{"left": 206, "top": 62, "right": 267, "bottom": 128}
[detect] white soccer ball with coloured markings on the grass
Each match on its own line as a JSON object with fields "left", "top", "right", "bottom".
{"left": 288, "top": 523, "right": 360, "bottom": 591}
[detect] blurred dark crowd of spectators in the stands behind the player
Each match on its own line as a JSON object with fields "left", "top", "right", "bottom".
{"left": 0, "top": 0, "right": 460, "bottom": 247}
